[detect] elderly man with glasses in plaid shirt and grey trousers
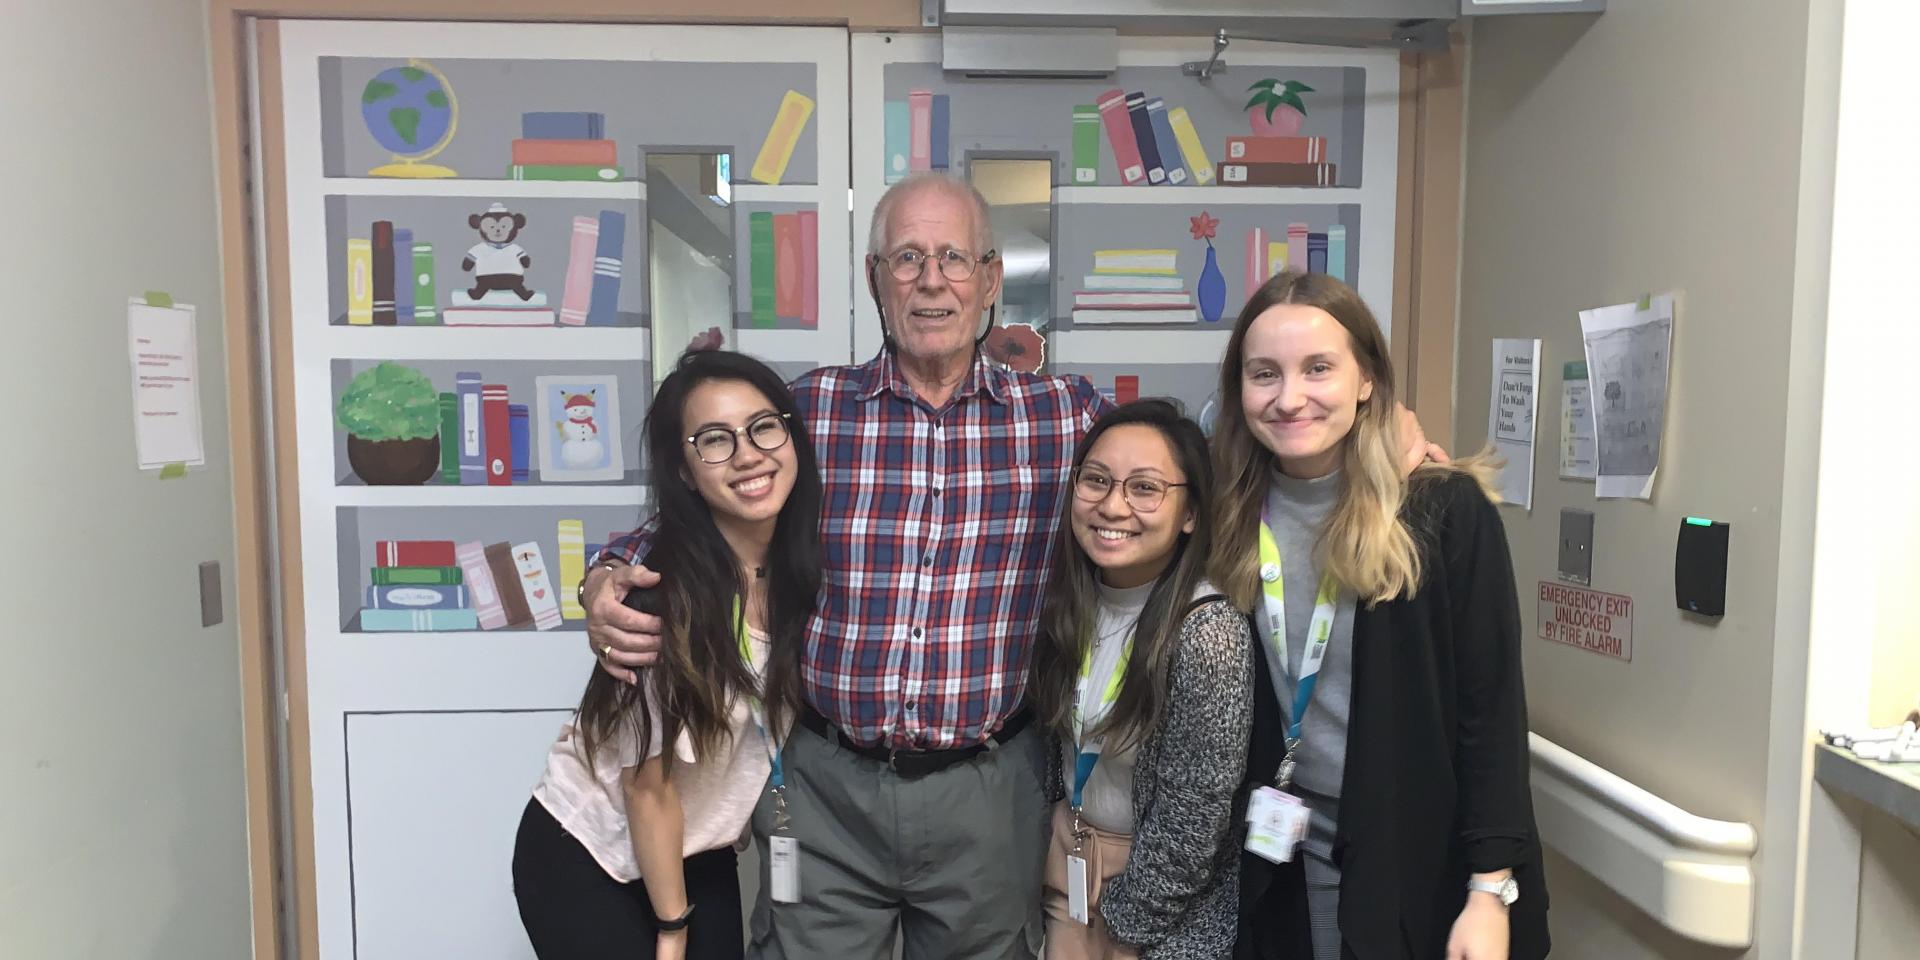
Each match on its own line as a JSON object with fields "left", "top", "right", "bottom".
{"left": 582, "top": 175, "right": 1427, "bottom": 960}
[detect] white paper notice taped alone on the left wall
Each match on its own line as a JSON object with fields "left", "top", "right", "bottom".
{"left": 127, "top": 298, "right": 207, "bottom": 470}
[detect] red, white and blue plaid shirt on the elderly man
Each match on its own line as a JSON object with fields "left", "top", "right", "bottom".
{"left": 605, "top": 349, "right": 1110, "bottom": 749}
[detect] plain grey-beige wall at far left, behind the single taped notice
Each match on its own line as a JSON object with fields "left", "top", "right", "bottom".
{"left": 0, "top": 0, "right": 250, "bottom": 960}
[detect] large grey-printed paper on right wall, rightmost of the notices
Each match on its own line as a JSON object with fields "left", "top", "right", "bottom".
{"left": 1580, "top": 294, "right": 1674, "bottom": 499}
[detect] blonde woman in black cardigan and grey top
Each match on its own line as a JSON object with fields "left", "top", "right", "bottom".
{"left": 1210, "top": 273, "right": 1548, "bottom": 960}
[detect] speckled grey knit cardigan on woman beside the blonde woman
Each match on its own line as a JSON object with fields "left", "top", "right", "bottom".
{"left": 1100, "top": 601, "right": 1254, "bottom": 960}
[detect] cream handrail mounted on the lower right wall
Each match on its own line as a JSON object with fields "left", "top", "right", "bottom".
{"left": 1528, "top": 733, "right": 1759, "bottom": 947}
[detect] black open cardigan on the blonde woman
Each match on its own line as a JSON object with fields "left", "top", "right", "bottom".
{"left": 1235, "top": 474, "right": 1549, "bottom": 960}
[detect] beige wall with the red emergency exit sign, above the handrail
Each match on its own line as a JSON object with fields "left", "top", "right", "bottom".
{"left": 1455, "top": 0, "right": 1809, "bottom": 960}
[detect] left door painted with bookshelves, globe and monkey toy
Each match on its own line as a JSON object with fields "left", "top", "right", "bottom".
{"left": 275, "top": 21, "right": 852, "bottom": 960}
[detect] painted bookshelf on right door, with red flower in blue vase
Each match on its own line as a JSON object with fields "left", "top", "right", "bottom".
{"left": 854, "top": 36, "right": 1400, "bottom": 424}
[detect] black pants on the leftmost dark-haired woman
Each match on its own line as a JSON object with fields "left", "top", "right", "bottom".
{"left": 513, "top": 801, "right": 747, "bottom": 960}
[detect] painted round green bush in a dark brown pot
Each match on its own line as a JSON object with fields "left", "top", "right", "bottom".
{"left": 334, "top": 361, "right": 440, "bottom": 486}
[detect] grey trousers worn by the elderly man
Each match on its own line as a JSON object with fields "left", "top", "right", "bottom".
{"left": 749, "top": 726, "right": 1048, "bottom": 960}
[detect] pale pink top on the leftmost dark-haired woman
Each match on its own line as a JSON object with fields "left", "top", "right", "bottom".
{"left": 534, "top": 630, "right": 772, "bottom": 883}
